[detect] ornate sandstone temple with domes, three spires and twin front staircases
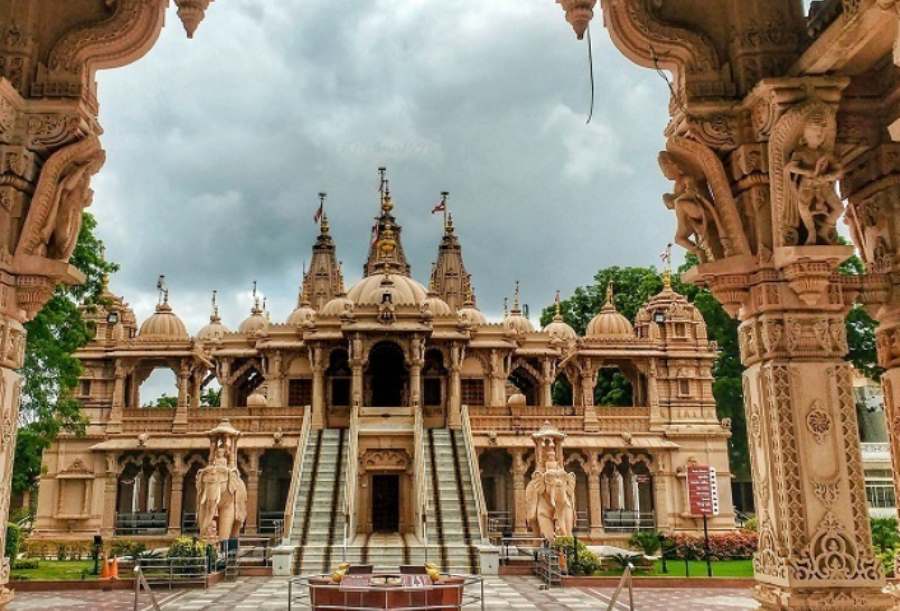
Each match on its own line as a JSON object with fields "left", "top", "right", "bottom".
{"left": 31, "top": 184, "right": 734, "bottom": 571}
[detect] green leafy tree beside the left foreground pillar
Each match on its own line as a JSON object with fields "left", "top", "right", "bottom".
{"left": 13, "top": 212, "right": 118, "bottom": 493}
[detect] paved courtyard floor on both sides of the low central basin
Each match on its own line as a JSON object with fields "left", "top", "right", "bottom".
{"left": 9, "top": 577, "right": 757, "bottom": 611}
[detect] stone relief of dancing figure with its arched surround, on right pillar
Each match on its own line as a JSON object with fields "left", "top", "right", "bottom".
{"left": 769, "top": 100, "right": 844, "bottom": 246}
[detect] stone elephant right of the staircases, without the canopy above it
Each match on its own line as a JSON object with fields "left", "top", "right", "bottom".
{"left": 525, "top": 469, "right": 575, "bottom": 542}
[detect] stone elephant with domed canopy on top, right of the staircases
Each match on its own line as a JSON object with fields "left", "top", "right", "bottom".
{"left": 525, "top": 422, "right": 575, "bottom": 543}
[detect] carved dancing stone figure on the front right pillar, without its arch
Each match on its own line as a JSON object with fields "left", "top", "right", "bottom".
{"left": 783, "top": 104, "right": 844, "bottom": 246}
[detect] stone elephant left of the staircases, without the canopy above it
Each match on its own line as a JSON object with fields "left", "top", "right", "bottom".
{"left": 197, "top": 465, "right": 247, "bottom": 541}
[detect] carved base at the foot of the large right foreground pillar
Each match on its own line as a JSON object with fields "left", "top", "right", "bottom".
{"left": 754, "top": 584, "right": 900, "bottom": 611}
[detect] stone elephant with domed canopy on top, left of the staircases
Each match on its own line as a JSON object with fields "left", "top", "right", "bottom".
{"left": 197, "top": 418, "right": 247, "bottom": 543}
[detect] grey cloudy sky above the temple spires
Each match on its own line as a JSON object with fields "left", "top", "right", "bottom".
{"left": 92, "top": 0, "right": 681, "bottom": 340}
